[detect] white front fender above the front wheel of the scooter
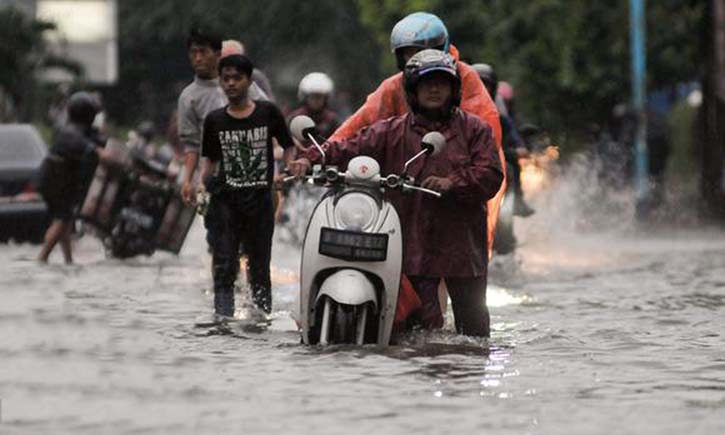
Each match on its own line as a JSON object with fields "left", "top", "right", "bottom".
{"left": 315, "top": 269, "right": 378, "bottom": 311}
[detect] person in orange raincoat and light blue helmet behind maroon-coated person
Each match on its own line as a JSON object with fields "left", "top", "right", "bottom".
{"left": 330, "top": 12, "right": 506, "bottom": 253}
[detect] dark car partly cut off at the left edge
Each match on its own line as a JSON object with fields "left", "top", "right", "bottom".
{"left": 0, "top": 124, "right": 49, "bottom": 243}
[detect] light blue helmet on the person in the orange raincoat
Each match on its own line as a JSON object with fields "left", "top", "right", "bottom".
{"left": 390, "top": 12, "right": 450, "bottom": 70}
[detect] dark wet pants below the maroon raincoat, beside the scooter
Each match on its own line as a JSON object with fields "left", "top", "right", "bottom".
{"left": 408, "top": 275, "right": 491, "bottom": 337}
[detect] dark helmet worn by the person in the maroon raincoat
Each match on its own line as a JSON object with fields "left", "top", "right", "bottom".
{"left": 403, "top": 49, "right": 461, "bottom": 113}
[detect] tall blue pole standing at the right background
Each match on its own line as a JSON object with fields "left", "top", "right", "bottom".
{"left": 629, "top": 0, "right": 649, "bottom": 201}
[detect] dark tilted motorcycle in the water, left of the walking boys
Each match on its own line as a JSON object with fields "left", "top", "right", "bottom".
{"left": 80, "top": 140, "right": 195, "bottom": 259}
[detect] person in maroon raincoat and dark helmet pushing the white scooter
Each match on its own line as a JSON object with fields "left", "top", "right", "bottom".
{"left": 290, "top": 49, "right": 504, "bottom": 336}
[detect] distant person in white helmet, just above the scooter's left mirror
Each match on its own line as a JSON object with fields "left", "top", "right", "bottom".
{"left": 287, "top": 72, "right": 340, "bottom": 138}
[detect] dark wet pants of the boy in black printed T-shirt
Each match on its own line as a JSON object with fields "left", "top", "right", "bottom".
{"left": 206, "top": 190, "right": 274, "bottom": 316}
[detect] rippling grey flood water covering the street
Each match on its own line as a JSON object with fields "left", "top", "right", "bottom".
{"left": 0, "top": 168, "right": 725, "bottom": 434}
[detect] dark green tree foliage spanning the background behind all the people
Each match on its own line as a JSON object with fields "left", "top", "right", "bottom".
{"left": 0, "top": 0, "right": 708, "bottom": 143}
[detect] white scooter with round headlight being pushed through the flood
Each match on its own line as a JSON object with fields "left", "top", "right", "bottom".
{"left": 290, "top": 116, "right": 445, "bottom": 346}
